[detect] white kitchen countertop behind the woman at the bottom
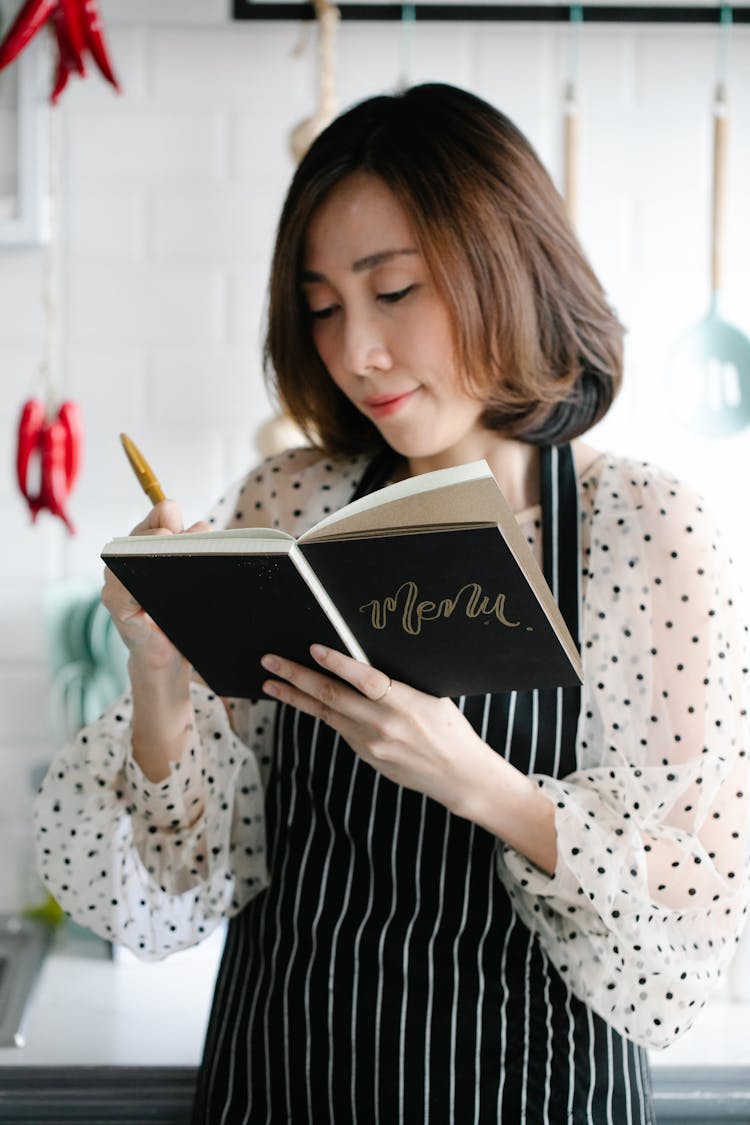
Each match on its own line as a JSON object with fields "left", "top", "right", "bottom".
{"left": 0, "top": 929, "right": 750, "bottom": 1067}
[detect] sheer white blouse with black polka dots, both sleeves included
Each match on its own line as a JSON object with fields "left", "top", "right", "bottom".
{"left": 34, "top": 450, "right": 748, "bottom": 1046}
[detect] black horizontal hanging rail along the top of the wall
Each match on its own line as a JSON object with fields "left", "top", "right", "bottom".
{"left": 232, "top": 0, "right": 750, "bottom": 24}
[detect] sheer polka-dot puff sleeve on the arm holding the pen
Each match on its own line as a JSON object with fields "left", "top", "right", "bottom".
{"left": 34, "top": 684, "right": 272, "bottom": 960}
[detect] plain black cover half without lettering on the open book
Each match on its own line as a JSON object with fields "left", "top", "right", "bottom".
{"left": 102, "top": 554, "right": 345, "bottom": 699}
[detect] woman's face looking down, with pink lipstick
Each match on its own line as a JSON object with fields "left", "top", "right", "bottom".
{"left": 301, "top": 172, "right": 488, "bottom": 468}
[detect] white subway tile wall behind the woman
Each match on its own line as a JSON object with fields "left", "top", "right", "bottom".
{"left": 0, "top": 0, "right": 750, "bottom": 910}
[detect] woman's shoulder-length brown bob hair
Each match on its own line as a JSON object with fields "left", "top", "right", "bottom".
{"left": 264, "top": 83, "right": 624, "bottom": 453}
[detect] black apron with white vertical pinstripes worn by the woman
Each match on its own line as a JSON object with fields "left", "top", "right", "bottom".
{"left": 193, "top": 446, "right": 652, "bottom": 1125}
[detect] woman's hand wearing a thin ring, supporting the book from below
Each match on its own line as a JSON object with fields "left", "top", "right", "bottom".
{"left": 261, "top": 645, "right": 507, "bottom": 816}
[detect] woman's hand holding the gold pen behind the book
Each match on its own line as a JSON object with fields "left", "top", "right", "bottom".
{"left": 101, "top": 500, "right": 210, "bottom": 672}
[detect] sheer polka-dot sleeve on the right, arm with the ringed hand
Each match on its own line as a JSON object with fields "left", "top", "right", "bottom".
{"left": 498, "top": 460, "right": 748, "bottom": 1047}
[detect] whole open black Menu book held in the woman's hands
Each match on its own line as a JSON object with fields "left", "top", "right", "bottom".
{"left": 102, "top": 461, "right": 580, "bottom": 699}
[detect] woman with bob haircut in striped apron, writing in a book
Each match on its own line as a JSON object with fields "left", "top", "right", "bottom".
{"left": 36, "top": 86, "right": 747, "bottom": 1125}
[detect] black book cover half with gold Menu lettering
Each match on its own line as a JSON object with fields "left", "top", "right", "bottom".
{"left": 302, "top": 527, "right": 580, "bottom": 696}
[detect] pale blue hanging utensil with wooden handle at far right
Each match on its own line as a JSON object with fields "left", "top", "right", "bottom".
{"left": 670, "top": 6, "right": 750, "bottom": 437}
